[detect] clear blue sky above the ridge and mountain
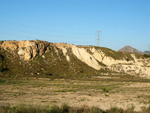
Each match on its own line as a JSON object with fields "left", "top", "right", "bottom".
{"left": 0, "top": 0, "right": 150, "bottom": 51}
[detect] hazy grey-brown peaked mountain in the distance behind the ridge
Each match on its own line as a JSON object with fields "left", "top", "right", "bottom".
{"left": 118, "top": 46, "right": 143, "bottom": 54}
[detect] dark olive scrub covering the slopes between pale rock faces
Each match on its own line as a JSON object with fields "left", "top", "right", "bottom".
{"left": 0, "top": 40, "right": 149, "bottom": 78}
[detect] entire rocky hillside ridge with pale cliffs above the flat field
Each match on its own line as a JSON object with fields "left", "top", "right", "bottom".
{"left": 0, "top": 40, "right": 150, "bottom": 78}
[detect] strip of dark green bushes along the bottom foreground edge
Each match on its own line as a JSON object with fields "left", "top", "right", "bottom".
{"left": 0, "top": 104, "right": 150, "bottom": 113}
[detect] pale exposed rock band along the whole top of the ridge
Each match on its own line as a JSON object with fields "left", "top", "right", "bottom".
{"left": 0, "top": 40, "right": 150, "bottom": 78}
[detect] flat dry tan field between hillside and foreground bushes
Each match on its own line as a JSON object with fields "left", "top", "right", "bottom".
{"left": 0, "top": 76, "right": 150, "bottom": 111}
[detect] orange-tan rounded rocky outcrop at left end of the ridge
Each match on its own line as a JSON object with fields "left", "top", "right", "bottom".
{"left": 1, "top": 40, "right": 50, "bottom": 61}
